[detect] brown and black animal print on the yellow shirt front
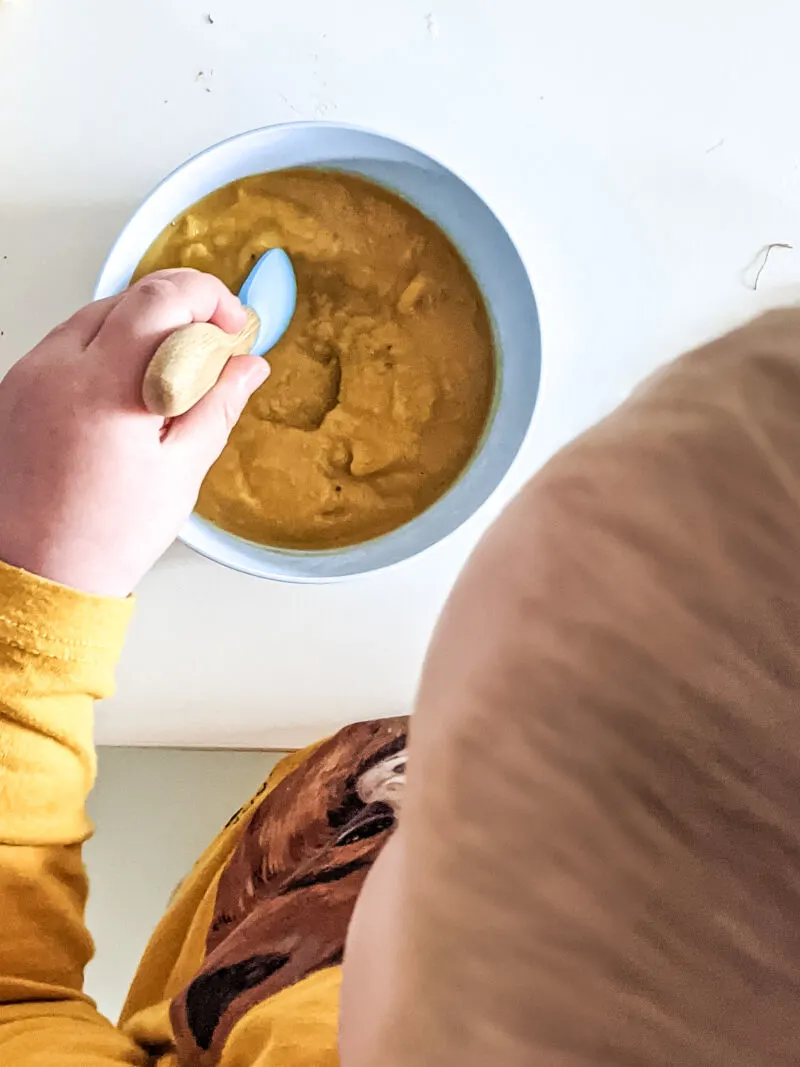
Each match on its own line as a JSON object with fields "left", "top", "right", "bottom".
{"left": 171, "top": 717, "right": 409, "bottom": 1067}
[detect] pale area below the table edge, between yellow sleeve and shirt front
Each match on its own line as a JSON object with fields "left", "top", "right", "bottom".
{"left": 85, "top": 748, "right": 281, "bottom": 1021}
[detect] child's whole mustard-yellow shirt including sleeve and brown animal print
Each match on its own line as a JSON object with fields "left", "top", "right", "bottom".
{"left": 0, "top": 564, "right": 405, "bottom": 1067}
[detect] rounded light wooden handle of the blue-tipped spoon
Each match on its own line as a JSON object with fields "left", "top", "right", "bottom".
{"left": 142, "top": 307, "right": 260, "bottom": 418}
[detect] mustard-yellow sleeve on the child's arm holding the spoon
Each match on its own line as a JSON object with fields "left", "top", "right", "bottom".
{"left": 0, "top": 563, "right": 147, "bottom": 1067}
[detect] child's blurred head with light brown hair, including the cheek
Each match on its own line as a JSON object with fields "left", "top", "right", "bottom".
{"left": 340, "top": 310, "right": 800, "bottom": 1067}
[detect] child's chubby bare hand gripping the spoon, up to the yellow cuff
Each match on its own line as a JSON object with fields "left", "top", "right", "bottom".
{"left": 0, "top": 270, "right": 269, "bottom": 596}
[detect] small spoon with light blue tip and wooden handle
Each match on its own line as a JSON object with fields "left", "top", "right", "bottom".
{"left": 142, "top": 249, "right": 298, "bottom": 418}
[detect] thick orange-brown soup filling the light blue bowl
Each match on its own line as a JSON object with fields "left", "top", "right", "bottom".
{"left": 137, "top": 170, "right": 495, "bottom": 550}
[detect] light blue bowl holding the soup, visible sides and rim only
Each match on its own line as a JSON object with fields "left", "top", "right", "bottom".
{"left": 95, "top": 123, "right": 542, "bottom": 583}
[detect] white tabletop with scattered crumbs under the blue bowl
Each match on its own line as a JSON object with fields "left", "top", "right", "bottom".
{"left": 0, "top": 0, "right": 800, "bottom": 747}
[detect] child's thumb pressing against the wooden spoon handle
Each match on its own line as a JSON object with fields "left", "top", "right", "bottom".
{"left": 167, "top": 355, "right": 270, "bottom": 466}
